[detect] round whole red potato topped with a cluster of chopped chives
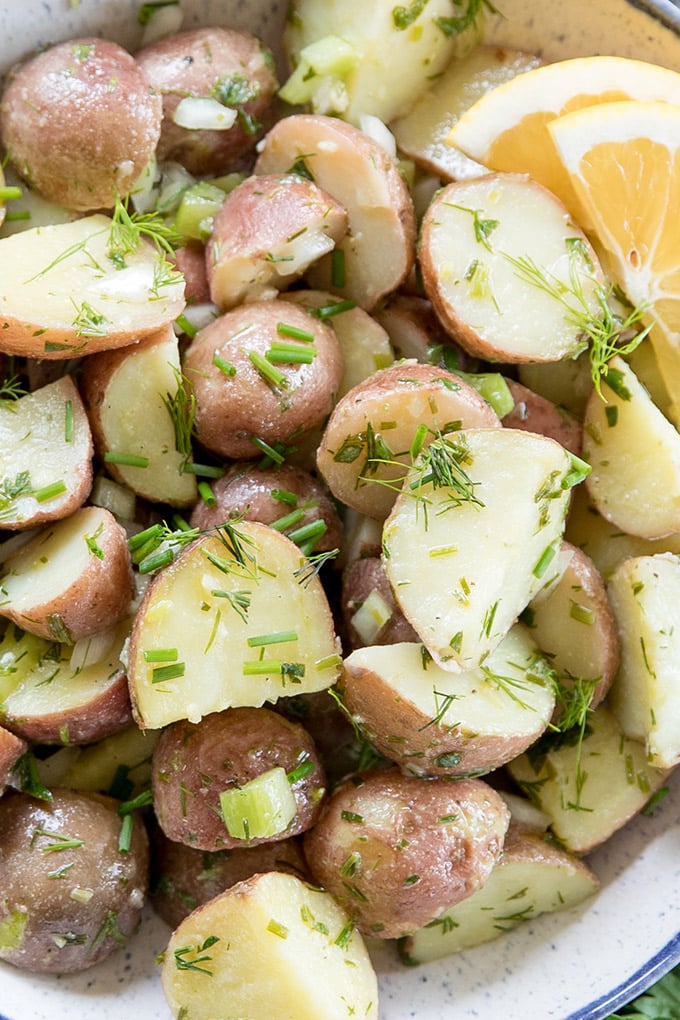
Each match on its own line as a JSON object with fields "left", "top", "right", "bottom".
{"left": 184, "top": 300, "right": 343, "bottom": 459}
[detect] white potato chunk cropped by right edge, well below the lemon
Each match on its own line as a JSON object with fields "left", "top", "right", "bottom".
{"left": 609, "top": 553, "right": 680, "bottom": 768}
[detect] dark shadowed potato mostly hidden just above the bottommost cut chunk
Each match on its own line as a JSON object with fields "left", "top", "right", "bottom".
{"left": 150, "top": 828, "right": 307, "bottom": 928}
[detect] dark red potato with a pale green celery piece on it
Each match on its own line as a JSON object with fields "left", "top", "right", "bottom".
{"left": 152, "top": 708, "right": 325, "bottom": 850}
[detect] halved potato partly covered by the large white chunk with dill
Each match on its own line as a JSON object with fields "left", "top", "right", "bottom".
{"left": 316, "top": 361, "right": 500, "bottom": 520}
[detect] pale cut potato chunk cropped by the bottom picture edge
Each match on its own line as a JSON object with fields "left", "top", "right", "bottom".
{"left": 161, "top": 872, "right": 378, "bottom": 1020}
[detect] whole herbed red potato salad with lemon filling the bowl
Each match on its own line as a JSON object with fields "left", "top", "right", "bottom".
{"left": 0, "top": 0, "right": 680, "bottom": 1020}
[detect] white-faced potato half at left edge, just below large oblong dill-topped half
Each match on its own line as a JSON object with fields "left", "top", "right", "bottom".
{"left": 0, "top": 377, "right": 92, "bottom": 528}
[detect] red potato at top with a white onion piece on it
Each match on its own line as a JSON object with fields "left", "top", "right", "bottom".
{"left": 137, "top": 28, "right": 277, "bottom": 174}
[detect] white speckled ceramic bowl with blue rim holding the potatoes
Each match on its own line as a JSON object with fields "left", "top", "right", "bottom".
{"left": 0, "top": 0, "right": 680, "bottom": 1020}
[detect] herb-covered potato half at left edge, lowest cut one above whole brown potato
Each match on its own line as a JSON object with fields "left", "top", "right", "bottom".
{"left": 0, "top": 620, "right": 132, "bottom": 745}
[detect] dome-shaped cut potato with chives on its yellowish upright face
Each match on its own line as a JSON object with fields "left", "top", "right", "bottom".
{"left": 127, "top": 521, "right": 342, "bottom": 729}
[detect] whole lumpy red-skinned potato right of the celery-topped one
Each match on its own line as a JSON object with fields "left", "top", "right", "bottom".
{"left": 304, "top": 768, "right": 510, "bottom": 938}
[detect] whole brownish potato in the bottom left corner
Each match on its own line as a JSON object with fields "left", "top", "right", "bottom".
{"left": 0, "top": 789, "right": 149, "bottom": 973}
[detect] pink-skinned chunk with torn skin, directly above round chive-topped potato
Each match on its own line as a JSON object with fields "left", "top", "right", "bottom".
{"left": 206, "top": 173, "right": 348, "bottom": 311}
